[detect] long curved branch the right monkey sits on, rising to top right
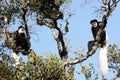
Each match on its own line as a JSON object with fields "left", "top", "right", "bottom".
{"left": 64, "top": 0, "right": 120, "bottom": 66}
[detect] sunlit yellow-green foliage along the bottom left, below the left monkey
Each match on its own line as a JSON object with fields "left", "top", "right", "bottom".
{"left": 0, "top": 53, "right": 73, "bottom": 80}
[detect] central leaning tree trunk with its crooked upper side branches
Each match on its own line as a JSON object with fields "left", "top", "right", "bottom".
{"left": 37, "top": 12, "right": 71, "bottom": 61}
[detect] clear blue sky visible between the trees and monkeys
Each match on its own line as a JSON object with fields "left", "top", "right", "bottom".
{"left": 7, "top": 0, "right": 120, "bottom": 80}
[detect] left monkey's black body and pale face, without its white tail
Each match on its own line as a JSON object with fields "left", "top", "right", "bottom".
{"left": 15, "top": 26, "right": 30, "bottom": 54}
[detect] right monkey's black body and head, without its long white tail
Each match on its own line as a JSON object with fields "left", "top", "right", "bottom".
{"left": 88, "top": 16, "right": 107, "bottom": 52}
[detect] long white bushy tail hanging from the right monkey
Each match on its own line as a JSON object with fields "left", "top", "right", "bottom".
{"left": 99, "top": 46, "right": 108, "bottom": 77}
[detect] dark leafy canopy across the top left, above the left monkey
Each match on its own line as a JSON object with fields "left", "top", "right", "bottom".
{"left": 0, "top": 0, "right": 67, "bottom": 21}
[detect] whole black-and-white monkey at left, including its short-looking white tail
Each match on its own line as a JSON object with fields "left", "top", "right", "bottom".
{"left": 13, "top": 26, "right": 30, "bottom": 66}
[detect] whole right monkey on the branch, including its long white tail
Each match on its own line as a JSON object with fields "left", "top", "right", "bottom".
{"left": 88, "top": 16, "right": 108, "bottom": 77}
